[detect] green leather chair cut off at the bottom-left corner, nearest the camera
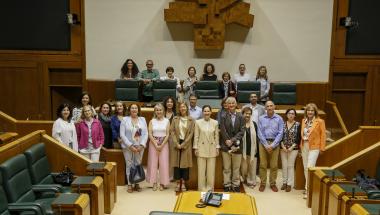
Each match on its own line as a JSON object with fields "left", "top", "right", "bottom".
{"left": 0, "top": 172, "right": 43, "bottom": 215}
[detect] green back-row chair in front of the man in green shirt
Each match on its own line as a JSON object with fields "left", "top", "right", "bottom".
{"left": 152, "top": 80, "right": 177, "bottom": 102}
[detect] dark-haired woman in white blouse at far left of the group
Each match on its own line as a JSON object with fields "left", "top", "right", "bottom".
{"left": 52, "top": 104, "right": 78, "bottom": 152}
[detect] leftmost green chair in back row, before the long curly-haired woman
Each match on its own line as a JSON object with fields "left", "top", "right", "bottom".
{"left": 115, "top": 79, "right": 140, "bottom": 101}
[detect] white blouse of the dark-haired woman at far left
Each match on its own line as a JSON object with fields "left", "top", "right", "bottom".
{"left": 52, "top": 118, "right": 78, "bottom": 152}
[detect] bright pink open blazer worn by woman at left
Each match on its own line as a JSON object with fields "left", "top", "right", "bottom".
{"left": 76, "top": 119, "right": 104, "bottom": 149}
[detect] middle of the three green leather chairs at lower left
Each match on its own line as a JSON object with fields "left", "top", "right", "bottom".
{"left": 0, "top": 154, "right": 58, "bottom": 214}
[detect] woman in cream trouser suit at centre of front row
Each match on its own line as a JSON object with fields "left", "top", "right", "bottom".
{"left": 193, "top": 105, "right": 220, "bottom": 191}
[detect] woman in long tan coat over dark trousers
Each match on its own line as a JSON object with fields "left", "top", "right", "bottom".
{"left": 170, "top": 103, "right": 195, "bottom": 192}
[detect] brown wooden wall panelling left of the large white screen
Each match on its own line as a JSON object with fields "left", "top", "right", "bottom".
{"left": 0, "top": 0, "right": 86, "bottom": 120}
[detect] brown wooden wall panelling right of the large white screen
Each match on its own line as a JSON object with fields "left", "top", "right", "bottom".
{"left": 328, "top": 0, "right": 380, "bottom": 130}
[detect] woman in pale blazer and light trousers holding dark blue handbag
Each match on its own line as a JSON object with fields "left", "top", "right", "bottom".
{"left": 120, "top": 103, "right": 148, "bottom": 193}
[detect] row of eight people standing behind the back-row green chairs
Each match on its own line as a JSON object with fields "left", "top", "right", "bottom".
{"left": 120, "top": 59, "right": 270, "bottom": 102}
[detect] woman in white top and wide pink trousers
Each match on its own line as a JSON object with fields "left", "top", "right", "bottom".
{"left": 146, "top": 103, "right": 170, "bottom": 191}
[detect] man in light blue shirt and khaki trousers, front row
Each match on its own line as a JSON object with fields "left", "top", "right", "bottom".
{"left": 258, "top": 101, "right": 284, "bottom": 192}
